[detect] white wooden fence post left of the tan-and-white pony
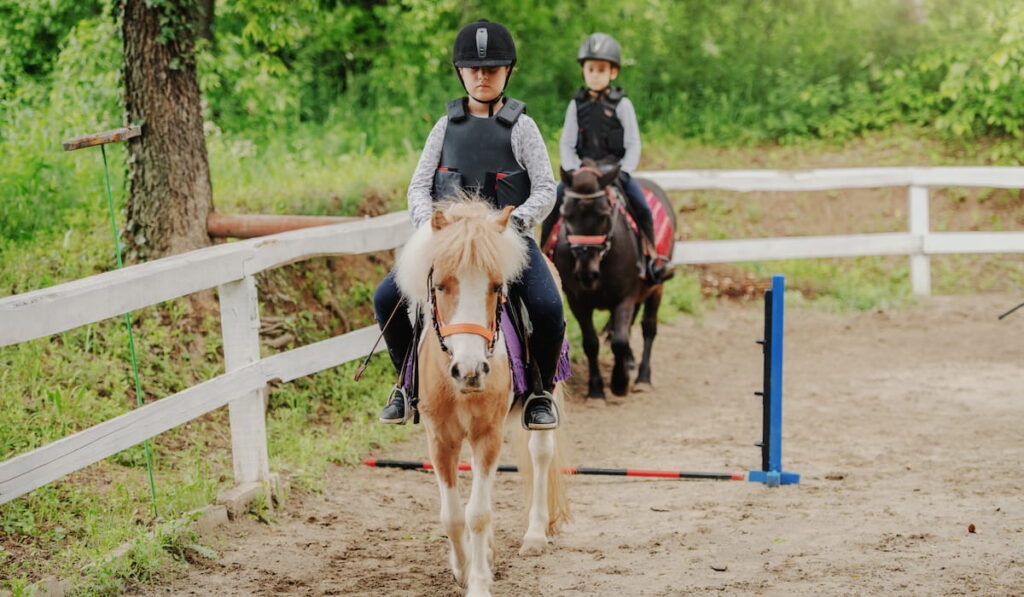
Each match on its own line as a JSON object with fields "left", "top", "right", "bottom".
{"left": 217, "top": 275, "right": 270, "bottom": 484}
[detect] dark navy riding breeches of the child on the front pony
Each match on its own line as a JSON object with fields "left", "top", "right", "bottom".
{"left": 374, "top": 233, "right": 565, "bottom": 389}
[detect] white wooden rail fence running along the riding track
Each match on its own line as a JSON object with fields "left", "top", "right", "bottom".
{"left": 0, "top": 168, "right": 1024, "bottom": 504}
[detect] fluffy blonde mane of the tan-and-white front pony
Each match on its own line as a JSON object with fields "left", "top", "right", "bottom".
{"left": 395, "top": 198, "right": 526, "bottom": 302}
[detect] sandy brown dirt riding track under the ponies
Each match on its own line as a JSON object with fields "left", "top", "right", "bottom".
{"left": 140, "top": 295, "right": 1024, "bottom": 597}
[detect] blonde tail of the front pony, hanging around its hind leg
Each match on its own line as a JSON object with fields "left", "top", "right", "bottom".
{"left": 512, "top": 382, "right": 572, "bottom": 537}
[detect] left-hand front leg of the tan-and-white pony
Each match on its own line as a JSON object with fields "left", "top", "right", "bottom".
{"left": 425, "top": 428, "right": 467, "bottom": 585}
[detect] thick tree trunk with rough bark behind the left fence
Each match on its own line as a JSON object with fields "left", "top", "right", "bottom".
{"left": 123, "top": 0, "right": 213, "bottom": 261}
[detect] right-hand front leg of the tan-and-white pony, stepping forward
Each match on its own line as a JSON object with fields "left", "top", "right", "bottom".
{"left": 466, "top": 425, "right": 502, "bottom": 597}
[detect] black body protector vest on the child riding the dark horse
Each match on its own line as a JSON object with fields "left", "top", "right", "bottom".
{"left": 572, "top": 87, "right": 626, "bottom": 162}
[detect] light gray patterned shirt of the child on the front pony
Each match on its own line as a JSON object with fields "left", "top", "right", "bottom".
{"left": 407, "top": 114, "right": 555, "bottom": 229}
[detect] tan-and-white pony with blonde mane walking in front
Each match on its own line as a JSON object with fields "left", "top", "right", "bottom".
{"left": 395, "top": 200, "right": 568, "bottom": 597}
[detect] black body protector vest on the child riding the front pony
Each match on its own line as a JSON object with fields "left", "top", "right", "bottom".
{"left": 433, "top": 97, "right": 530, "bottom": 208}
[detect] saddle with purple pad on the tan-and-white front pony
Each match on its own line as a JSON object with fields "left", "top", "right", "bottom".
{"left": 398, "top": 292, "right": 572, "bottom": 423}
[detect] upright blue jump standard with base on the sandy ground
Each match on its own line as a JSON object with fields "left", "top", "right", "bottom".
{"left": 746, "top": 274, "right": 800, "bottom": 487}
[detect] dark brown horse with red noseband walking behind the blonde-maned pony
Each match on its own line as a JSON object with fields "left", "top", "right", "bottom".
{"left": 554, "top": 161, "right": 676, "bottom": 403}
